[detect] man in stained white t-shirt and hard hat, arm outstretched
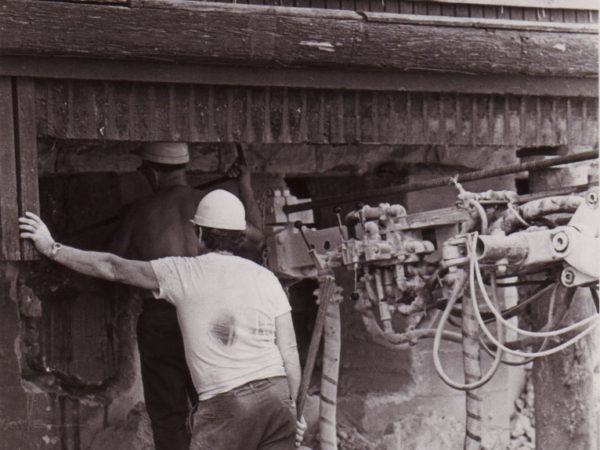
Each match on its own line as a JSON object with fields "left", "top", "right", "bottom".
{"left": 19, "top": 190, "right": 306, "bottom": 450}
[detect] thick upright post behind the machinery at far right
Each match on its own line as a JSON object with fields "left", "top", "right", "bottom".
{"left": 529, "top": 148, "right": 600, "bottom": 450}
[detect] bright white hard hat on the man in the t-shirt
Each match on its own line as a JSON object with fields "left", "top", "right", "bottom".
{"left": 191, "top": 189, "right": 246, "bottom": 231}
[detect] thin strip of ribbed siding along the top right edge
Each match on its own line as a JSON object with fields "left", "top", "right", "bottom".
{"left": 217, "top": 0, "right": 598, "bottom": 23}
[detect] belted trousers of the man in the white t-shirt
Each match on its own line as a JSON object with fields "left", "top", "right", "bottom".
{"left": 190, "top": 377, "right": 296, "bottom": 450}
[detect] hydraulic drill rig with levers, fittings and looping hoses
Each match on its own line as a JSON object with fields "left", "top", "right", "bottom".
{"left": 266, "top": 153, "right": 600, "bottom": 449}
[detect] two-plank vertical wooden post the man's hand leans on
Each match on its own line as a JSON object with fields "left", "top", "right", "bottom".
{"left": 0, "top": 77, "right": 39, "bottom": 261}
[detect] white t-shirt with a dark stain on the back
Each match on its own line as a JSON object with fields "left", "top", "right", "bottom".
{"left": 151, "top": 253, "right": 291, "bottom": 400}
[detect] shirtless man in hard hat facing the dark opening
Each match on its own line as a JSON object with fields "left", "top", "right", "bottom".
{"left": 108, "top": 142, "right": 261, "bottom": 450}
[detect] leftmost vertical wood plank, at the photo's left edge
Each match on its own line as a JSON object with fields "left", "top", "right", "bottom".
{"left": 0, "top": 77, "right": 21, "bottom": 261}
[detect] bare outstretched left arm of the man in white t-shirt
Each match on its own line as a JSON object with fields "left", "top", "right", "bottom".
{"left": 19, "top": 212, "right": 159, "bottom": 290}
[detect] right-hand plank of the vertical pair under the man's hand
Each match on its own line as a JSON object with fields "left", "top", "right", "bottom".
{"left": 14, "top": 78, "right": 40, "bottom": 260}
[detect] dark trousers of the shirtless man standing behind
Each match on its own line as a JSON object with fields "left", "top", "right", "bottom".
{"left": 137, "top": 299, "right": 198, "bottom": 450}
